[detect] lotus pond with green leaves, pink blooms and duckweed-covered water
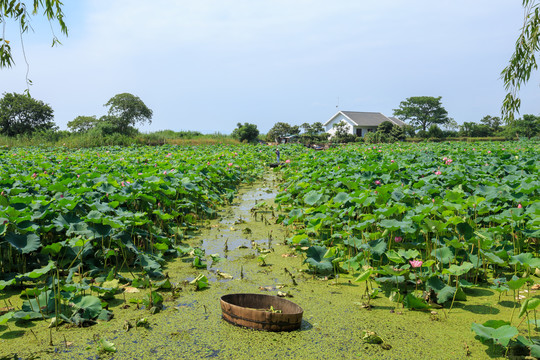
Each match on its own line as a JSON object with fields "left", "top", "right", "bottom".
{"left": 0, "top": 142, "right": 540, "bottom": 359}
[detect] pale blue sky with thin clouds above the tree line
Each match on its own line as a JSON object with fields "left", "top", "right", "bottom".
{"left": 0, "top": 0, "right": 540, "bottom": 134}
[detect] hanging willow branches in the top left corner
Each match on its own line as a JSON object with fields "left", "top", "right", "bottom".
{"left": 0, "top": 0, "right": 68, "bottom": 68}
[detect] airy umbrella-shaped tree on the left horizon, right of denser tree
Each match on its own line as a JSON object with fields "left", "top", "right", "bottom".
{"left": 104, "top": 93, "right": 152, "bottom": 132}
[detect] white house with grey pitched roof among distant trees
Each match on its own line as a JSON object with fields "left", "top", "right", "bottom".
{"left": 324, "top": 111, "right": 405, "bottom": 137}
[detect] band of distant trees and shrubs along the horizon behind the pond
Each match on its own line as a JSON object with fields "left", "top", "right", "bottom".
{"left": 0, "top": 93, "right": 540, "bottom": 148}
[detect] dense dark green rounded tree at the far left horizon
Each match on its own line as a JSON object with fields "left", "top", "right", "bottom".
{"left": 0, "top": 93, "right": 55, "bottom": 136}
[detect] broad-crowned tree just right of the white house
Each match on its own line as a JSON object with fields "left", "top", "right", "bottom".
{"left": 394, "top": 96, "right": 449, "bottom": 131}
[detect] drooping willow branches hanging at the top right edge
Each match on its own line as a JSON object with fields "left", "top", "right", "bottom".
{"left": 501, "top": 0, "right": 540, "bottom": 124}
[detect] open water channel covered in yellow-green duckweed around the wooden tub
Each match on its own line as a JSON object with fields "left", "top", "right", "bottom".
{"left": 0, "top": 174, "right": 532, "bottom": 359}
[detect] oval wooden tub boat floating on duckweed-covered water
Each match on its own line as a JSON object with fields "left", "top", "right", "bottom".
{"left": 220, "top": 294, "right": 304, "bottom": 331}
